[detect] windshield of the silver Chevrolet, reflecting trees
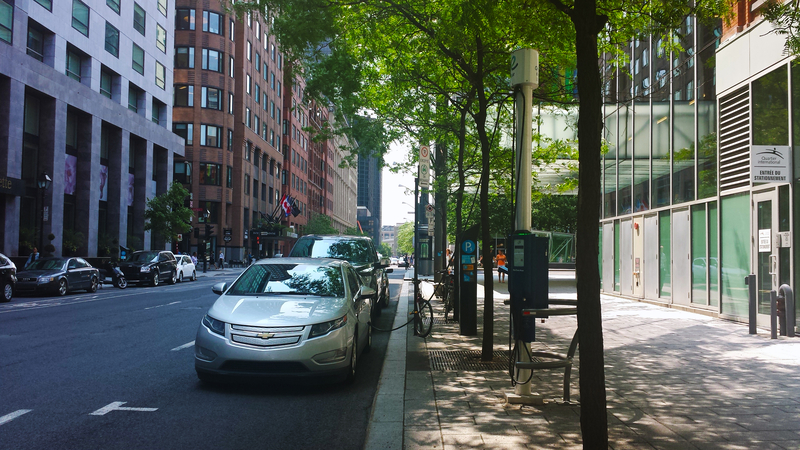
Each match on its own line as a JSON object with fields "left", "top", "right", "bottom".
{"left": 226, "top": 264, "right": 344, "bottom": 297}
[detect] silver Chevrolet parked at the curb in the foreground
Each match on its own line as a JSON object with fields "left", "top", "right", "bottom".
{"left": 194, "top": 258, "right": 375, "bottom": 381}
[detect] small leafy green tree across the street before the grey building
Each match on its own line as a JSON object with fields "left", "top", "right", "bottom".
{"left": 144, "top": 183, "right": 192, "bottom": 247}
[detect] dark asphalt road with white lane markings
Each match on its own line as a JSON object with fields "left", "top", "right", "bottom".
{"left": 0, "top": 271, "right": 402, "bottom": 450}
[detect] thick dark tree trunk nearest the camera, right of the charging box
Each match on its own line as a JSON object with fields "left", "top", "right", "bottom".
{"left": 571, "top": 0, "right": 608, "bottom": 449}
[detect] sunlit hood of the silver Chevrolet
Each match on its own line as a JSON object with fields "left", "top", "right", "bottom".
{"left": 208, "top": 294, "right": 347, "bottom": 326}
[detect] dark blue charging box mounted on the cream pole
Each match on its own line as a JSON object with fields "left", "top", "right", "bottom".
{"left": 507, "top": 234, "right": 550, "bottom": 342}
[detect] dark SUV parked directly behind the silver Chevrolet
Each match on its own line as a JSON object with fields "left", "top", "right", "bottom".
{"left": 289, "top": 234, "right": 393, "bottom": 307}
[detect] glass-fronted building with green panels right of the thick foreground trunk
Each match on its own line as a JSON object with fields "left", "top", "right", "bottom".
{"left": 600, "top": 12, "right": 800, "bottom": 332}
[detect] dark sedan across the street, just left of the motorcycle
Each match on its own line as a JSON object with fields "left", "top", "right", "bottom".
{"left": 15, "top": 257, "right": 100, "bottom": 295}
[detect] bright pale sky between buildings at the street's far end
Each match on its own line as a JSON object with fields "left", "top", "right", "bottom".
{"left": 381, "top": 143, "right": 416, "bottom": 229}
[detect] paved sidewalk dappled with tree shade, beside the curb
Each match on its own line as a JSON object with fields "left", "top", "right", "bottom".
{"left": 365, "top": 271, "right": 800, "bottom": 450}
